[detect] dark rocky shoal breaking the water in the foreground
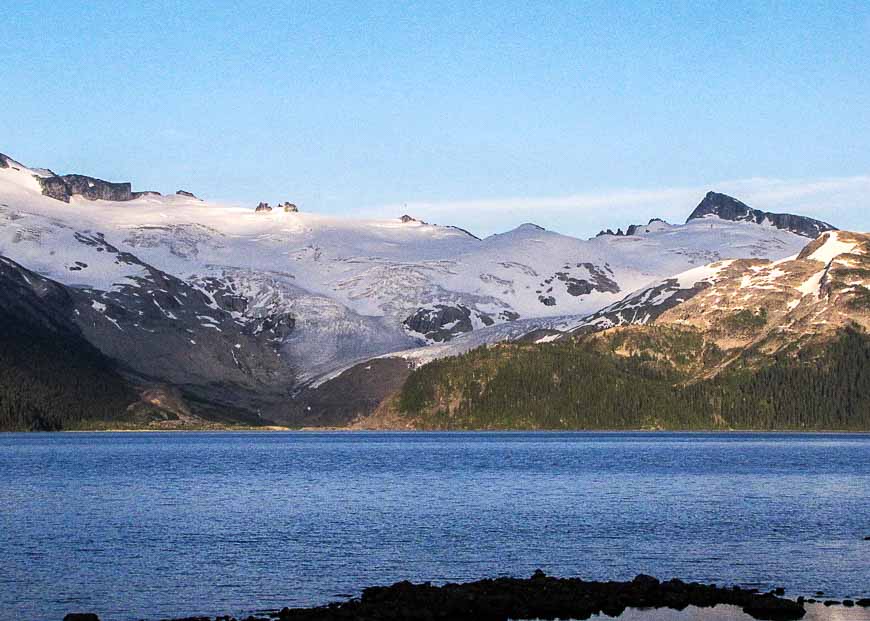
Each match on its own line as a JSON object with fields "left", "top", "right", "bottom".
{"left": 64, "top": 570, "right": 870, "bottom": 621}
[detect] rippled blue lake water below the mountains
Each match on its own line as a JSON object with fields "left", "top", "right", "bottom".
{"left": 0, "top": 433, "right": 870, "bottom": 621}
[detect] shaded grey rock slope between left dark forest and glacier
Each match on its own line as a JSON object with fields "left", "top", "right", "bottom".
{"left": 0, "top": 233, "right": 295, "bottom": 428}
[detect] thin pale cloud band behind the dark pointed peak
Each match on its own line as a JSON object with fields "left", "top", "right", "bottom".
{"left": 365, "top": 175, "right": 870, "bottom": 237}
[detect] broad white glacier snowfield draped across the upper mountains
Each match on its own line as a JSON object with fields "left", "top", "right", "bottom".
{"left": 0, "top": 160, "right": 816, "bottom": 379}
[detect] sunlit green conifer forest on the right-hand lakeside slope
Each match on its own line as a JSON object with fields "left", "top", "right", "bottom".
{"left": 398, "top": 328, "right": 870, "bottom": 430}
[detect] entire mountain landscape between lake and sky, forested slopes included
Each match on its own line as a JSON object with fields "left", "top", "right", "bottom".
{"left": 0, "top": 154, "right": 870, "bottom": 430}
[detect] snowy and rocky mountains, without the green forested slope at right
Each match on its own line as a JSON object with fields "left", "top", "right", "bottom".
{"left": 0, "top": 154, "right": 870, "bottom": 429}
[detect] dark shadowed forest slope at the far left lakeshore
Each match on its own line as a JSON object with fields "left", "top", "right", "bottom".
{"left": 0, "top": 311, "right": 136, "bottom": 431}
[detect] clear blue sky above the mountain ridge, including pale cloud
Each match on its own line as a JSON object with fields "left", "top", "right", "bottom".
{"left": 0, "top": 0, "right": 870, "bottom": 236}
